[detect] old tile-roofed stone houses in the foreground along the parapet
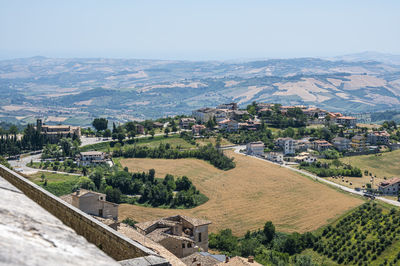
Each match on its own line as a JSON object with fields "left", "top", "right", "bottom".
{"left": 61, "top": 189, "right": 261, "bottom": 266}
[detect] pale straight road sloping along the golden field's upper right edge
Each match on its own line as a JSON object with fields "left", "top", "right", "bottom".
{"left": 234, "top": 146, "right": 400, "bottom": 207}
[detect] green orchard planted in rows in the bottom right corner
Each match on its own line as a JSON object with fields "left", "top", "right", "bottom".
{"left": 313, "top": 203, "right": 400, "bottom": 265}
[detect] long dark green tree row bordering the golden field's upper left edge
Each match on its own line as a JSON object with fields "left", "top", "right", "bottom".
{"left": 120, "top": 143, "right": 235, "bottom": 170}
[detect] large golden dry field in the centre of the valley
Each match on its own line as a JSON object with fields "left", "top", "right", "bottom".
{"left": 119, "top": 151, "right": 362, "bottom": 235}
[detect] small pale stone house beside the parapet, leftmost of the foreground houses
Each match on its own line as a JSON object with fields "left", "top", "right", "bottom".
{"left": 61, "top": 189, "right": 118, "bottom": 220}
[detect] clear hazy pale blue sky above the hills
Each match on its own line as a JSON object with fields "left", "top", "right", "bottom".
{"left": 0, "top": 0, "right": 400, "bottom": 60}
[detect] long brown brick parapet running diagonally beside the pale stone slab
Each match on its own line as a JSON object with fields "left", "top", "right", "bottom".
{"left": 0, "top": 165, "right": 168, "bottom": 265}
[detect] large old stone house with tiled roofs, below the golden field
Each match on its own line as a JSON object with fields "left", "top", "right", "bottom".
{"left": 135, "top": 215, "right": 211, "bottom": 258}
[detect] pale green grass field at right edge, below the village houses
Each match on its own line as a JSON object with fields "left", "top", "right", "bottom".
{"left": 341, "top": 150, "right": 400, "bottom": 178}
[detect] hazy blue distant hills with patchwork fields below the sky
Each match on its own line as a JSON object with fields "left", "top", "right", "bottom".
{"left": 0, "top": 52, "right": 400, "bottom": 125}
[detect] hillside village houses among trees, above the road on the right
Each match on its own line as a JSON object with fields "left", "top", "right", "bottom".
{"left": 187, "top": 103, "right": 400, "bottom": 195}
